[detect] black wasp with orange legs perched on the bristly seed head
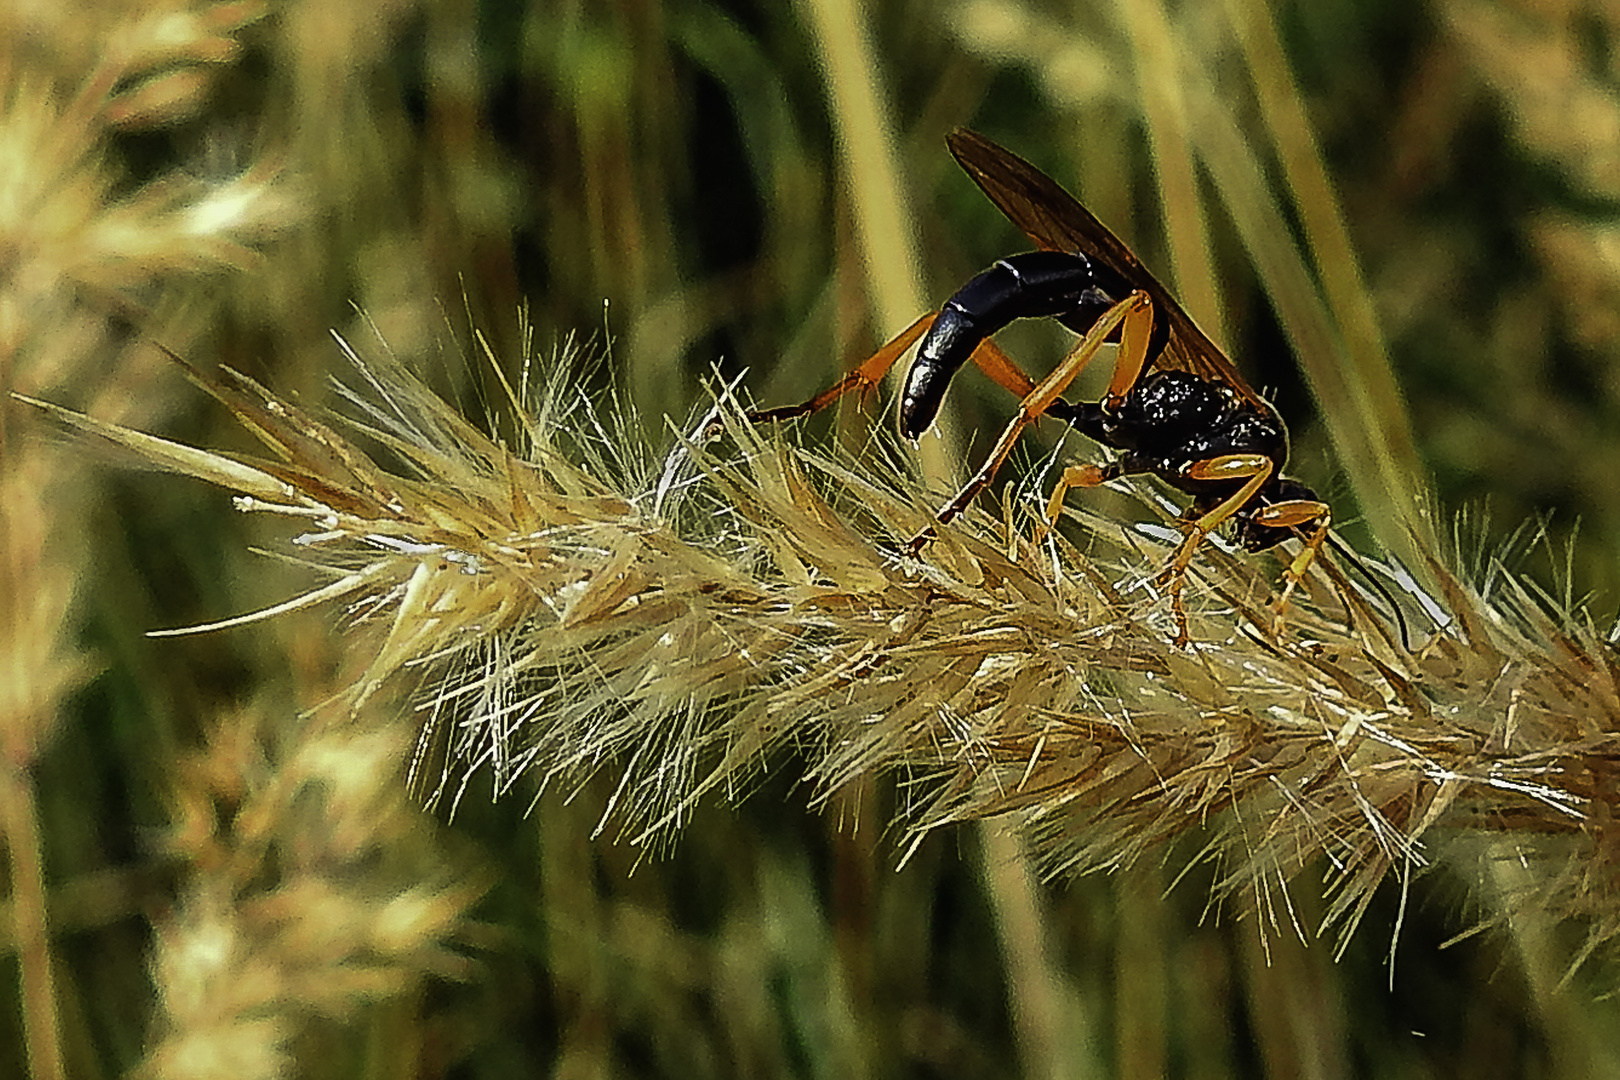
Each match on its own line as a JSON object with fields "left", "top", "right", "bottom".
{"left": 750, "top": 130, "right": 1332, "bottom": 644}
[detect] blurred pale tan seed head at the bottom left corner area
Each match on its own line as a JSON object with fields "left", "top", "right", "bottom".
{"left": 141, "top": 709, "right": 476, "bottom": 1080}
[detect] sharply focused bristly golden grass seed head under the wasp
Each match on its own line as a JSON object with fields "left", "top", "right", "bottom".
{"left": 19, "top": 331, "right": 1620, "bottom": 971}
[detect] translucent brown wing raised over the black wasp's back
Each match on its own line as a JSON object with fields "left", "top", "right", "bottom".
{"left": 946, "top": 128, "right": 1270, "bottom": 410}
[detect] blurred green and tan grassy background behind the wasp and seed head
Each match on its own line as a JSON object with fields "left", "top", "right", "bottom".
{"left": 0, "top": 0, "right": 1620, "bottom": 1077}
